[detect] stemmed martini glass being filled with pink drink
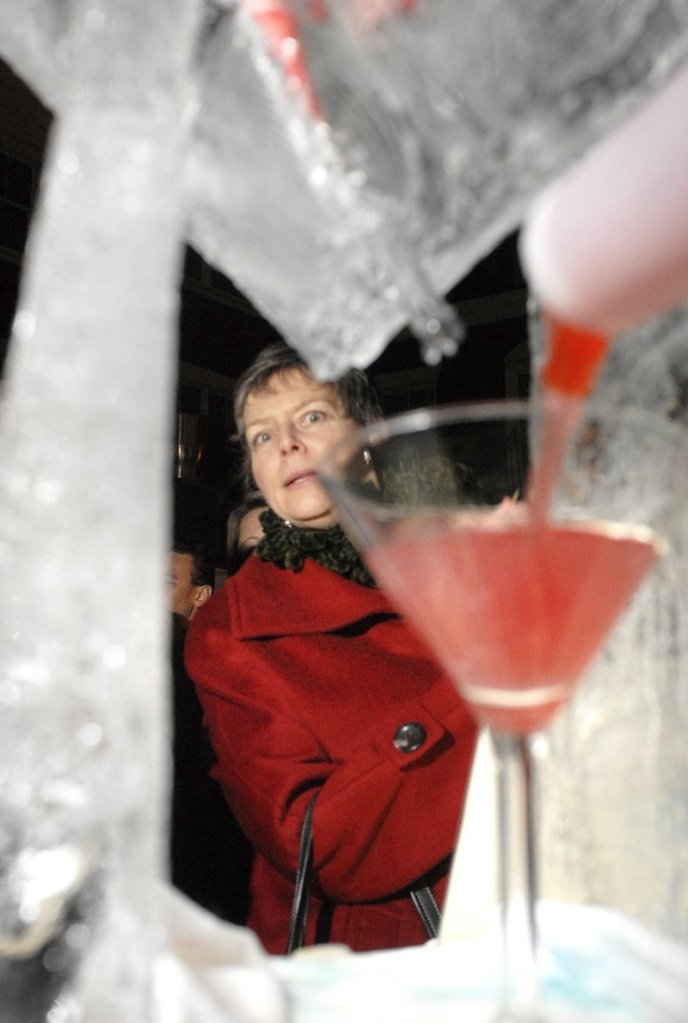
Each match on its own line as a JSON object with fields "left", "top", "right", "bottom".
{"left": 319, "top": 402, "right": 686, "bottom": 1023}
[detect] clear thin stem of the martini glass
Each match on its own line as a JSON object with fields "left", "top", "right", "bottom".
{"left": 491, "top": 731, "right": 542, "bottom": 1023}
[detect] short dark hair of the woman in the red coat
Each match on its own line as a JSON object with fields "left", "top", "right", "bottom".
{"left": 234, "top": 342, "right": 382, "bottom": 491}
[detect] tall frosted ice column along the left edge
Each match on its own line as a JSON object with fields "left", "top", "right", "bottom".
{"left": 0, "top": 0, "right": 198, "bottom": 1023}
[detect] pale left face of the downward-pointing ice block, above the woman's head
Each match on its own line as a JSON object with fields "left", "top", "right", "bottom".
{"left": 181, "top": 3, "right": 458, "bottom": 375}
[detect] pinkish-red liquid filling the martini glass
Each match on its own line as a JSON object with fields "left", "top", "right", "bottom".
{"left": 367, "top": 519, "right": 659, "bottom": 735}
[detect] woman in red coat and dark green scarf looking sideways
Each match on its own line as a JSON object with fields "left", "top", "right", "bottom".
{"left": 186, "top": 345, "right": 475, "bottom": 953}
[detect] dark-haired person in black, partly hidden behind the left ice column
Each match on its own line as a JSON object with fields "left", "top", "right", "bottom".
{"left": 170, "top": 538, "right": 251, "bottom": 924}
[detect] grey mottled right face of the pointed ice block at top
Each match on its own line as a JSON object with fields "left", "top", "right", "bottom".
{"left": 318, "top": 0, "right": 688, "bottom": 315}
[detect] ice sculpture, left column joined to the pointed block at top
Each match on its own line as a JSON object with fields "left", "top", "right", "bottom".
{"left": 0, "top": 0, "right": 688, "bottom": 1023}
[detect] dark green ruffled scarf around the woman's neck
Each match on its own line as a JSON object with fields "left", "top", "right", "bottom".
{"left": 254, "top": 508, "right": 375, "bottom": 586}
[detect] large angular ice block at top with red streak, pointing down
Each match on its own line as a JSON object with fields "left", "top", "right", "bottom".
{"left": 179, "top": 0, "right": 688, "bottom": 375}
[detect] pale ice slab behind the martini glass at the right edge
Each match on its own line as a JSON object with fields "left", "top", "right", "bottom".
{"left": 532, "top": 307, "right": 688, "bottom": 941}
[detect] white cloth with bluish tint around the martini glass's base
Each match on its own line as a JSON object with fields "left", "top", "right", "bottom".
{"left": 157, "top": 890, "right": 688, "bottom": 1023}
